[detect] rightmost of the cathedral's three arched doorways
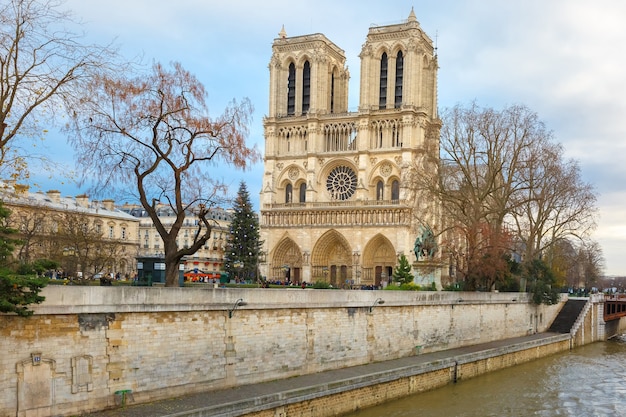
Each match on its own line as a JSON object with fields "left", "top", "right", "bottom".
{"left": 361, "top": 234, "right": 397, "bottom": 286}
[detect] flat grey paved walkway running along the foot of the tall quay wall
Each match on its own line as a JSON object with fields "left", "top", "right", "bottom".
{"left": 86, "top": 333, "right": 567, "bottom": 417}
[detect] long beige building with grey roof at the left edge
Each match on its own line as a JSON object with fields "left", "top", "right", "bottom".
{"left": 0, "top": 182, "right": 139, "bottom": 278}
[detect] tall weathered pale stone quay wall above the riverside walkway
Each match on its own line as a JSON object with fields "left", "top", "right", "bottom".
{"left": 0, "top": 286, "right": 561, "bottom": 417}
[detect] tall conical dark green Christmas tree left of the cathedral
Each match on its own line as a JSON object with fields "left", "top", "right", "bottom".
{"left": 224, "top": 181, "right": 263, "bottom": 281}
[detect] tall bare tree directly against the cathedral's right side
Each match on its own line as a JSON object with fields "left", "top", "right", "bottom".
{"left": 428, "top": 103, "right": 550, "bottom": 289}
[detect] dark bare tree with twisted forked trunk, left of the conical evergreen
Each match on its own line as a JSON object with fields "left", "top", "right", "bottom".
{"left": 73, "top": 63, "right": 260, "bottom": 286}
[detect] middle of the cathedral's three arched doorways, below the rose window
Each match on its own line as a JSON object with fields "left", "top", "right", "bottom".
{"left": 311, "top": 230, "right": 352, "bottom": 288}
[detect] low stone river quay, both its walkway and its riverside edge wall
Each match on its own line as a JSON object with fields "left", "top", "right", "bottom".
{"left": 86, "top": 333, "right": 570, "bottom": 417}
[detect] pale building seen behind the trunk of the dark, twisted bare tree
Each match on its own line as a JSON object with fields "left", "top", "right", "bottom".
{"left": 122, "top": 204, "right": 232, "bottom": 282}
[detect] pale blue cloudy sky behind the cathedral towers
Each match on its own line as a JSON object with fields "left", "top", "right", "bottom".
{"left": 28, "top": 0, "right": 626, "bottom": 276}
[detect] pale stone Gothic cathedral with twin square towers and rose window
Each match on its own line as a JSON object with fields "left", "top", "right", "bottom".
{"left": 260, "top": 10, "right": 445, "bottom": 288}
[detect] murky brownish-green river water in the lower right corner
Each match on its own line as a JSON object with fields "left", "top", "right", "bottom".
{"left": 348, "top": 335, "right": 626, "bottom": 417}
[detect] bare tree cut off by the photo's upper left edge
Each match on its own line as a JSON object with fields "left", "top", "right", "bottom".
{"left": 0, "top": 0, "right": 113, "bottom": 179}
